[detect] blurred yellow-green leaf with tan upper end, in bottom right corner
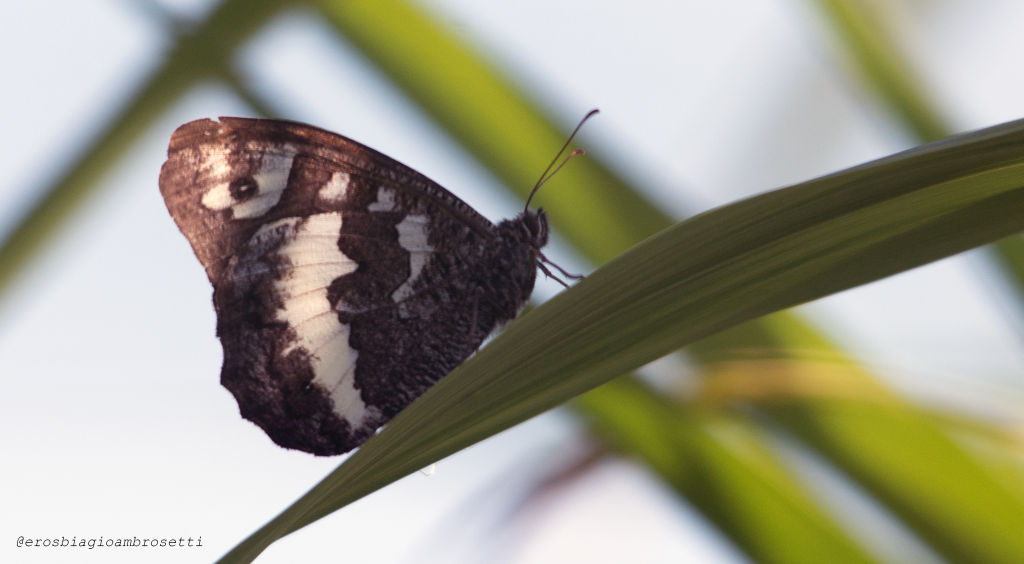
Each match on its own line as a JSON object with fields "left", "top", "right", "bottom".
{"left": 700, "top": 359, "right": 1024, "bottom": 563}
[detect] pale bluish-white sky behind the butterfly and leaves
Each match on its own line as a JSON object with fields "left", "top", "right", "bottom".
{"left": 0, "top": 0, "right": 1024, "bottom": 564}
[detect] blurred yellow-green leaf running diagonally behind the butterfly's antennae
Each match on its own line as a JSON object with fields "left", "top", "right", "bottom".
{"left": 316, "top": 0, "right": 671, "bottom": 263}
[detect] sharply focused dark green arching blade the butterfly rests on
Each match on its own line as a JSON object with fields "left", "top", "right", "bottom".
{"left": 216, "top": 117, "right": 1024, "bottom": 562}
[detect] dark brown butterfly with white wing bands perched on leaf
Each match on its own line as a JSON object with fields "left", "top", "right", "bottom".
{"left": 154, "top": 116, "right": 589, "bottom": 455}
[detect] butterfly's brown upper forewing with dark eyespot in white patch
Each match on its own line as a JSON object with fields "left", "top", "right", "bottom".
{"left": 160, "top": 118, "right": 494, "bottom": 283}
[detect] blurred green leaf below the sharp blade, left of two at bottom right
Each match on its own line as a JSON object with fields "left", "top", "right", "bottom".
{"left": 579, "top": 378, "right": 874, "bottom": 564}
